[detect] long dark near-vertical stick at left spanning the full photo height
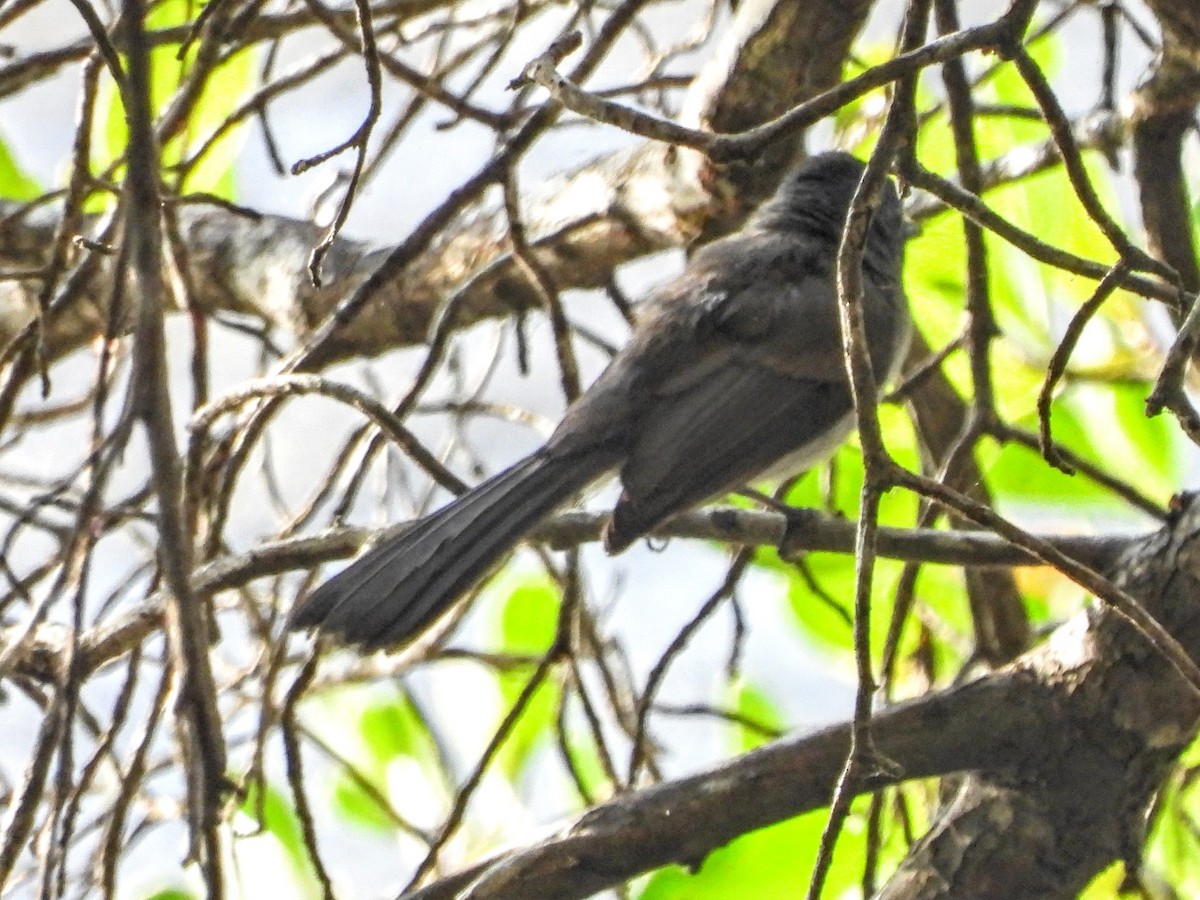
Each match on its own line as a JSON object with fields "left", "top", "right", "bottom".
{"left": 118, "top": 0, "right": 227, "bottom": 900}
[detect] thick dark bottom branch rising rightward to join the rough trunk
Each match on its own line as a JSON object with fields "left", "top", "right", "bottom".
{"left": 404, "top": 676, "right": 1041, "bottom": 900}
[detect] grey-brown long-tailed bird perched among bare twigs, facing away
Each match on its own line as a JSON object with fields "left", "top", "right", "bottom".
{"left": 288, "top": 151, "right": 911, "bottom": 650}
